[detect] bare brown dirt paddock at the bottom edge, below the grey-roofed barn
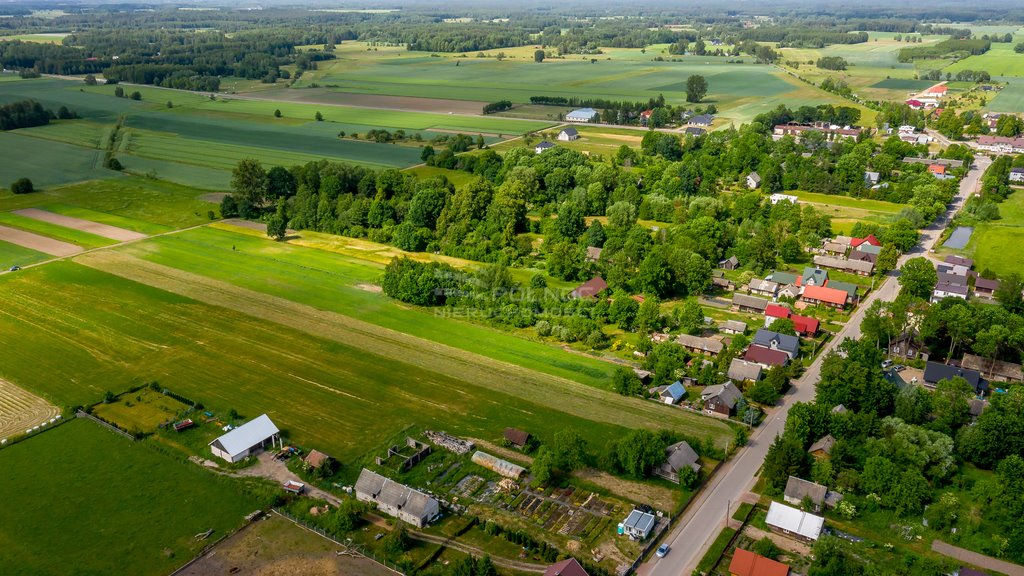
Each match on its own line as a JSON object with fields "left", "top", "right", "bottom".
{"left": 180, "top": 515, "right": 394, "bottom": 576}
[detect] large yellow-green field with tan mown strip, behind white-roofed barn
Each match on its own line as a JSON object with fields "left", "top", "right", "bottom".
{"left": 0, "top": 255, "right": 731, "bottom": 461}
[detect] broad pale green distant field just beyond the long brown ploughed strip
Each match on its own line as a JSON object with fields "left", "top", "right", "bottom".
{"left": 297, "top": 42, "right": 864, "bottom": 122}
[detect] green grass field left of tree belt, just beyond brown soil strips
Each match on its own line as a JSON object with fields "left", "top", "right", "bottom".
{"left": 0, "top": 177, "right": 216, "bottom": 228}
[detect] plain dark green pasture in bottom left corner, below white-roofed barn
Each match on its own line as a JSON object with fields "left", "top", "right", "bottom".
{"left": 0, "top": 420, "right": 261, "bottom": 576}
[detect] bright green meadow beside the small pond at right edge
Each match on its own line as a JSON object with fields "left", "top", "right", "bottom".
{"left": 965, "top": 190, "right": 1024, "bottom": 277}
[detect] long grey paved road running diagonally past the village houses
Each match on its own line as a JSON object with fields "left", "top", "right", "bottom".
{"left": 639, "top": 158, "right": 990, "bottom": 576}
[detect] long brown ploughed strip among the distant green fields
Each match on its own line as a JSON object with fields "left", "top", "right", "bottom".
{"left": 245, "top": 88, "right": 487, "bottom": 115}
